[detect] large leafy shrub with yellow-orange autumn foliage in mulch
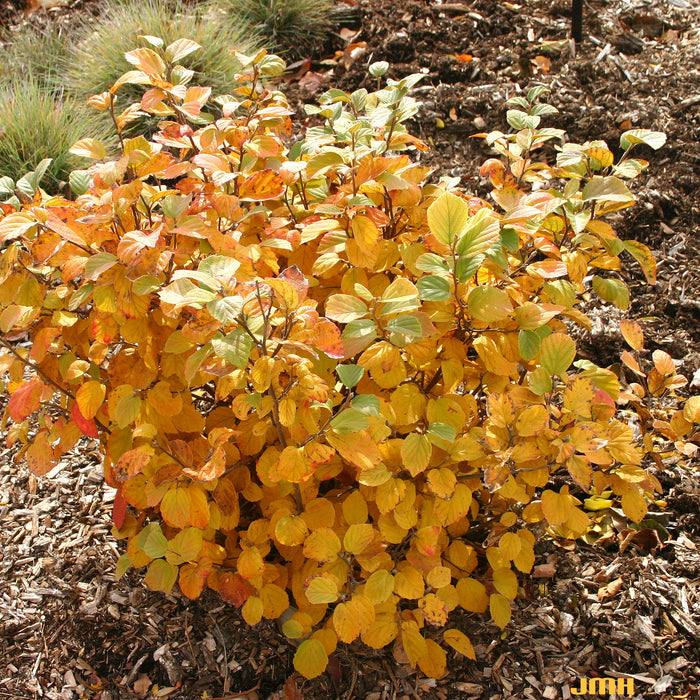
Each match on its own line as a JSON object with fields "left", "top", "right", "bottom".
{"left": 0, "top": 37, "right": 700, "bottom": 678}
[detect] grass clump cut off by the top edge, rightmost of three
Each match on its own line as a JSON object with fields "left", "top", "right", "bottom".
{"left": 213, "top": 0, "right": 333, "bottom": 57}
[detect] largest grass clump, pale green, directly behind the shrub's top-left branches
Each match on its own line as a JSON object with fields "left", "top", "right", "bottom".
{"left": 65, "top": 0, "right": 259, "bottom": 133}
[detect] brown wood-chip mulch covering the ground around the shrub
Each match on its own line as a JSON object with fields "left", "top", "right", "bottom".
{"left": 0, "top": 0, "right": 700, "bottom": 700}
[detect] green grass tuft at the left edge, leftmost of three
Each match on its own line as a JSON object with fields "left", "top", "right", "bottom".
{"left": 0, "top": 78, "right": 109, "bottom": 193}
